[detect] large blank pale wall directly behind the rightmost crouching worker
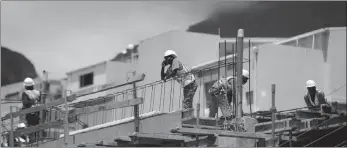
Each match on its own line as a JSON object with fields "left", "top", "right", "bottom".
{"left": 255, "top": 44, "right": 324, "bottom": 110}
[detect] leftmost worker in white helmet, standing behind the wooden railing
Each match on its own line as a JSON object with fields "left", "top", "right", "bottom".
{"left": 22, "top": 78, "right": 40, "bottom": 142}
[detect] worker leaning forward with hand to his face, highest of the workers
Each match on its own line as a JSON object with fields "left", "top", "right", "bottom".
{"left": 161, "top": 50, "right": 198, "bottom": 109}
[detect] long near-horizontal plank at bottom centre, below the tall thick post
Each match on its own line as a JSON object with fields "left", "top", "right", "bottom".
{"left": 173, "top": 128, "right": 271, "bottom": 139}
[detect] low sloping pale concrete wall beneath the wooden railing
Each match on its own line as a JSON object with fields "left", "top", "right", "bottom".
{"left": 40, "top": 112, "right": 181, "bottom": 147}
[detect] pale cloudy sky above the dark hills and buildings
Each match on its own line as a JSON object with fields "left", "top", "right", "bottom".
{"left": 1, "top": 1, "right": 256, "bottom": 79}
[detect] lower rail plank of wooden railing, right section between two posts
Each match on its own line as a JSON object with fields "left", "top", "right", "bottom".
{"left": 71, "top": 98, "right": 143, "bottom": 115}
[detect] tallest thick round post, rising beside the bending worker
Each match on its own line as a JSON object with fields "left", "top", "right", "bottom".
{"left": 236, "top": 29, "right": 244, "bottom": 119}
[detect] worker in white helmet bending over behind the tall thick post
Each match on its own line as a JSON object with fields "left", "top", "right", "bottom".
{"left": 209, "top": 69, "right": 249, "bottom": 118}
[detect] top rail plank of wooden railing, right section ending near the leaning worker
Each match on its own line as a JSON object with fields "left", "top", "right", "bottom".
{"left": 74, "top": 74, "right": 146, "bottom": 97}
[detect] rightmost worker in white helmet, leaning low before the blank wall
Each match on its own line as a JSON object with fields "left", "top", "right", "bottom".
{"left": 304, "top": 80, "right": 331, "bottom": 114}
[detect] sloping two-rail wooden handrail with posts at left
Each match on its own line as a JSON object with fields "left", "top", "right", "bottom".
{"left": 1, "top": 74, "right": 145, "bottom": 146}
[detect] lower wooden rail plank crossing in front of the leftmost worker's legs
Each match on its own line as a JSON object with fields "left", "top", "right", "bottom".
{"left": 14, "top": 119, "right": 64, "bottom": 136}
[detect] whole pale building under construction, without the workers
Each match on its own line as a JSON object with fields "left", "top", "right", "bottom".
{"left": 2, "top": 27, "right": 347, "bottom": 147}
